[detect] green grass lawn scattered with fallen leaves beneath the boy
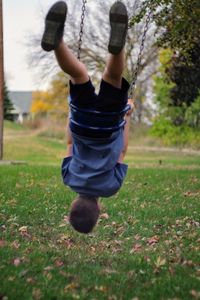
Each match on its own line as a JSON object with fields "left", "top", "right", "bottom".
{"left": 0, "top": 122, "right": 200, "bottom": 300}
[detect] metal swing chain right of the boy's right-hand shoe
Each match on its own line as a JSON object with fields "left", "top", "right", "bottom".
{"left": 129, "top": 9, "right": 153, "bottom": 99}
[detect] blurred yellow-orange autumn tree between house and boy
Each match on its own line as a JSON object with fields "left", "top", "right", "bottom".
{"left": 31, "top": 72, "right": 68, "bottom": 119}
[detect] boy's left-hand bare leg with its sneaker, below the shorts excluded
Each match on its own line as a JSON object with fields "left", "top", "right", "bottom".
{"left": 41, "top": 1, "right": 89, "bottom": 84}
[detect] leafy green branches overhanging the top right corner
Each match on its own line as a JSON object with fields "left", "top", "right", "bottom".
{"left": 131, "top": 0, "right": 200, "bottom": 53}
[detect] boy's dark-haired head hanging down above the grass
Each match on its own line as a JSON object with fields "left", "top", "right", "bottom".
{"left": 69, "top": 195, "right": 100, "bottom": 233}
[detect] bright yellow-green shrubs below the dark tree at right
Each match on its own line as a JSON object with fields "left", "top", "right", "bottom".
{"left": 150, "top": 49, "right": 200, "bottom": 147}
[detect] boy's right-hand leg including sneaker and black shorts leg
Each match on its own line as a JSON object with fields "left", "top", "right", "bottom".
{"left": 96, "top": 1, "right": 129, "bottom": 112}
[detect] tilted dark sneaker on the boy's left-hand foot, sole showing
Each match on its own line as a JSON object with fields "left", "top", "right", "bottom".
{"left": 41, "top": 1, "right": 67, "bottom": 51}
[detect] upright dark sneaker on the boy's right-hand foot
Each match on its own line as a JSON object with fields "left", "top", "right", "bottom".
{"left": 108, "top": 1, "right": 128, "bottom": 55}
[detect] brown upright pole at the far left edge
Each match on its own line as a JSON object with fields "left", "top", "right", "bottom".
{"left": 0, "top": 0, "right": 4, "bottom": 160}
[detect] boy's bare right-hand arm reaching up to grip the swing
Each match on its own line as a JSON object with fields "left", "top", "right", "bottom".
{"left": 118, "top": 99, "right": 135, "bottom": 163}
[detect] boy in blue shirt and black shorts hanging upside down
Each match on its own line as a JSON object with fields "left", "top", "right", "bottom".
{"left": 41, "top": 1, "right": 133, "bottom": 233}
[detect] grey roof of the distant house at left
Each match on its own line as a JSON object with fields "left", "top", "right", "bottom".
{"left": 8, "top": 91, "right": 32, "bottom": 113}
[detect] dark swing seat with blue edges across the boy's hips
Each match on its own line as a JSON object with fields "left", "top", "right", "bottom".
{"left": 69, "top": 103, "right": 131, "bottom": 133}
